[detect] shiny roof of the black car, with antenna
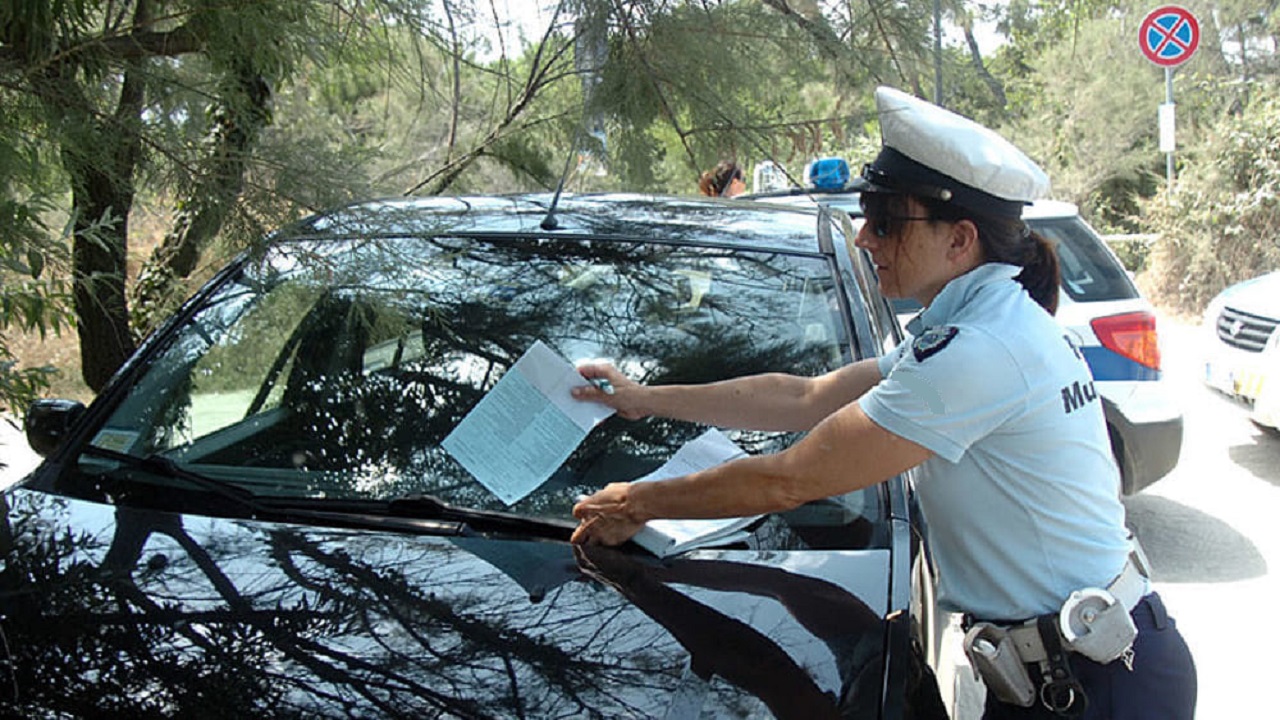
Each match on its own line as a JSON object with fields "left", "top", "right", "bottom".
{"left": 282, "top": 193, "right": 819, "bottom": 254}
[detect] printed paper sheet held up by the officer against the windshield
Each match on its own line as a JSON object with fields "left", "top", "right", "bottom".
{"left": 440, "top": 341, "right": 613, "bottom": 505}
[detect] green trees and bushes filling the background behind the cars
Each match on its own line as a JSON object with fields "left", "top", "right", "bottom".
{"left": 0, "top": 0, "right": 1277, "bottom": 393}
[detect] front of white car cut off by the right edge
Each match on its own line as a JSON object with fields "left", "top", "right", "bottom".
{"left": 1204, "top": 270, "right": 1280, "bottom": 429}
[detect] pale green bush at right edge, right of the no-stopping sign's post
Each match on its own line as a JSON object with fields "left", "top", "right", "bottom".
{"left": 1144, "top": 83, "right": 1280, "bottom": 313}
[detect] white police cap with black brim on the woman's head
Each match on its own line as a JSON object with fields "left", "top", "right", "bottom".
{"left": 852, "top": 87, "right": 1048, "bottom": 218}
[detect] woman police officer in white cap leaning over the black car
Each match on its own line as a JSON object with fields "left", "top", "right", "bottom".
{"left": 573, "top": 87, "right": 1196, "bottom": 720}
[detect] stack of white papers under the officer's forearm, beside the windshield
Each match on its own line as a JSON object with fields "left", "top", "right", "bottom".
{"left": 632, "top": 428, "right": 760, "bottom": 557}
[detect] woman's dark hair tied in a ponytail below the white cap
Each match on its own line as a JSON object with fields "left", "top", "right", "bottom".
{"left": 861, "top": 192, "right": 1062, "bottom": 315}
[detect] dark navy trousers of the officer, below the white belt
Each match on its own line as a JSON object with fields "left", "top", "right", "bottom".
{"left": 983, "top": 593, "right": 1196, "bottom": 720}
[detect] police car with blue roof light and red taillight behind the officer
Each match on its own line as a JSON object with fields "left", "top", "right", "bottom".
{"left": 739, "top": 158, "right": 1183, "bottom": 495}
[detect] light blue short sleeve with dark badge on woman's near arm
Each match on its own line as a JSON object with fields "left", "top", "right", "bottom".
{"left": 859, "top": 325, "right": 1028, "bottom": 462}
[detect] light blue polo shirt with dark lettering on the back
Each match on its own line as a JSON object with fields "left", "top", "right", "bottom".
{"left": 859, "top": 263, "right": 1129, "bottom": 620}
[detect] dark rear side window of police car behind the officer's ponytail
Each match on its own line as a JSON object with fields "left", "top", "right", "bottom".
{"left": 1028, "top": 218, "right": 1138, "bottom": 302}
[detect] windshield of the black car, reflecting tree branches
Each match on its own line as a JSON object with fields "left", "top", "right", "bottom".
{"left": 70, "top": 229, "right": 877, "bottom": 543}
